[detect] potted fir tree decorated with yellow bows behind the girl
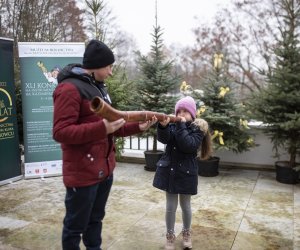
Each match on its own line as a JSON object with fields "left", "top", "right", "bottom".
{"left": 180, "top": 53, "right": 255, "bottom": 176}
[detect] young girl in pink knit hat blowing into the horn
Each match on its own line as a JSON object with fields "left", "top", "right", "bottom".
{"left": 153, "top": 96, "right": 212, "bottom": 250}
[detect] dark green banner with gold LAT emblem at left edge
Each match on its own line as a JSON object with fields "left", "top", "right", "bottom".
{"left": 0, "top": 37, "right": 22, "bottom": 185}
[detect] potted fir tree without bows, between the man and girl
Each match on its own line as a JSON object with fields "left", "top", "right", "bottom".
{"left": 135, "top": 22, "right": 180, "bottom": 171}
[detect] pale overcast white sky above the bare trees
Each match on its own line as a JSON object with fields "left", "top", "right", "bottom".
{"left": 107, "top": 0, "right": 230, "bottom": 53}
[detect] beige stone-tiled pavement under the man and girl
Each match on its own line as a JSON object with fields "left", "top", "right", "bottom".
{"left": 0, "top": 163, "right": 300, "bottom": 250}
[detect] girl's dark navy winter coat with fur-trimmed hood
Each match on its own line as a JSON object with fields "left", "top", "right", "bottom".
{"left": 153, "top": 122, "right": 204, "bottom": 195}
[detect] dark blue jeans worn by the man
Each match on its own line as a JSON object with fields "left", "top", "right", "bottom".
{"left": 62, "top": 176, "right": 113, "bottom": 250}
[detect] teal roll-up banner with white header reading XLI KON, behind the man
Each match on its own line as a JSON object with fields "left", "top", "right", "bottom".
{"left": 18, "top": 43, "right": 85, "bottom": 178}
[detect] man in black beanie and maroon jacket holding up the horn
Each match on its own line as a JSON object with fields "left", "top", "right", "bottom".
{"left": 53, "top": 40, "right": 157, "bottom": 250}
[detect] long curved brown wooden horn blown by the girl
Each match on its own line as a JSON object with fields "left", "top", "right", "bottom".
{"left": 90, "top": 96, "right": 180, "bottom": 122}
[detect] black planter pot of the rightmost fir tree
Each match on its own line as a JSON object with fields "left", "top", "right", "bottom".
{"left": 275, "top": 161, "right": 300, "bottom": 184}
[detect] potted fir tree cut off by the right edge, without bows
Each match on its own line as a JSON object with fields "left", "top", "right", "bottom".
{"left": 250, "top": 1, "right": 300, "bottom": 184}
